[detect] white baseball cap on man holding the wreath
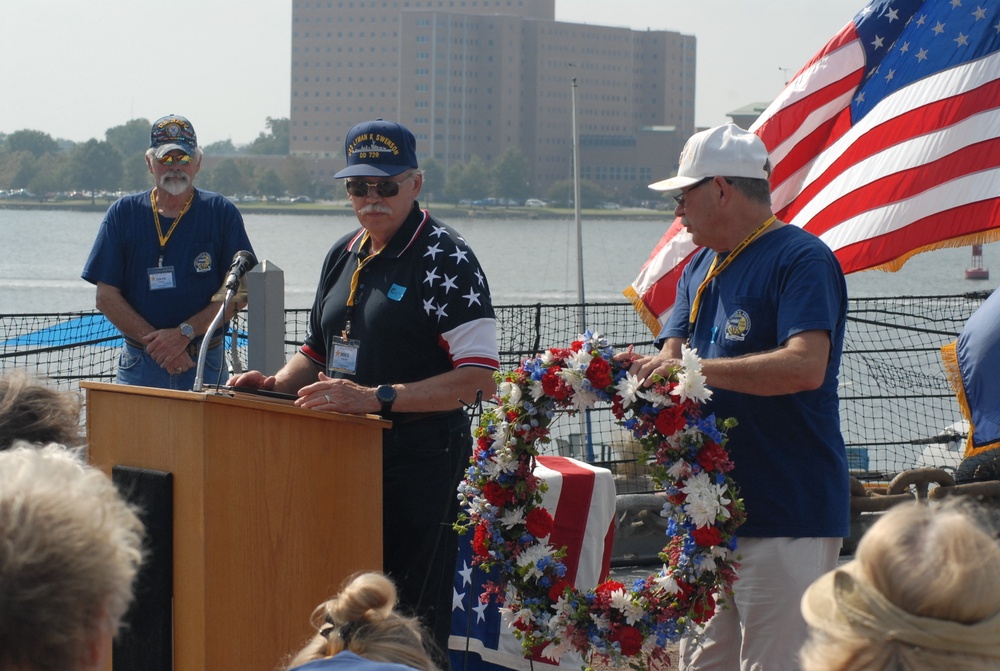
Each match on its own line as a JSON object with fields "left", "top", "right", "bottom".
{"left": 649, "top": 123, "right": 768, "bottom": 191}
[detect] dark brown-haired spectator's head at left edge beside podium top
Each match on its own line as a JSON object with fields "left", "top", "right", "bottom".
{"left": 0, "top": 371, "right": 83, "bottom": 450}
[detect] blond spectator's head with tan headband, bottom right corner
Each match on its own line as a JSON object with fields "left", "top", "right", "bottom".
{"left": 802, "top": 501, "right": 1000, "bottom": 671}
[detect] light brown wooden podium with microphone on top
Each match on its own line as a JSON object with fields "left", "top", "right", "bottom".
{"left": 80, "top": 382, "right": 390, "bottom": 671}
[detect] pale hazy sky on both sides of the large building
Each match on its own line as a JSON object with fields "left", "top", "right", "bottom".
{"left": 0, "top": 0, "right": 865, "bottom": 145}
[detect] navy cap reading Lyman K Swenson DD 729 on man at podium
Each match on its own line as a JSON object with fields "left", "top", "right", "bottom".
{"left": 334, "top": 119, "right": 417, "bottom": 179}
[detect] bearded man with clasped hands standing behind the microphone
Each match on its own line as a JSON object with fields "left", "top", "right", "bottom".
{"left": 82, "top": 114, "right": 253, "bottom": 389}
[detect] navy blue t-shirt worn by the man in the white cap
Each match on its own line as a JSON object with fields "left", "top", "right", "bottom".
{"left": 660, "top": 226, "right": 850, "bottom": 538}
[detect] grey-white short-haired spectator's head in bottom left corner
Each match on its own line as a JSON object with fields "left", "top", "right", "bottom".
{"left": 0, "top": 443, "right": 143, "bottom": 671}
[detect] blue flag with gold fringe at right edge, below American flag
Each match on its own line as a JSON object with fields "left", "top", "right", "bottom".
{"left": 941, "top": 291, "right": 1000, "bottom": 457}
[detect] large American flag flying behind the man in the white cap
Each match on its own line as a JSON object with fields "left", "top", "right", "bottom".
{"left": 624, "top": 0, "right": 1000, "bottom": 335}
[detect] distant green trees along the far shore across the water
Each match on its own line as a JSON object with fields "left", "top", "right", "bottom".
{"left": 0, "top": 117, "right": 670, "bottom": 210}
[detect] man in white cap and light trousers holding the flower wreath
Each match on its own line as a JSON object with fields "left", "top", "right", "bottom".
{"left": 632, "top": 124, "right": 850, "bottom": 670}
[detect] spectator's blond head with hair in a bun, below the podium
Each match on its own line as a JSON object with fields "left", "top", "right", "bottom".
{"left": 288, "top": 573, "right": 437, "bottom": 671}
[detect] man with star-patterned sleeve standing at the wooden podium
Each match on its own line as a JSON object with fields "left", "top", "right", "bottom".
{"left": 229, "top": 119, "right": 499, "bottom": 663}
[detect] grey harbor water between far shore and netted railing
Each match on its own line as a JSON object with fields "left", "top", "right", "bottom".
{"left": 0, "top": 207, "right": 1000, "bottom": 314}
